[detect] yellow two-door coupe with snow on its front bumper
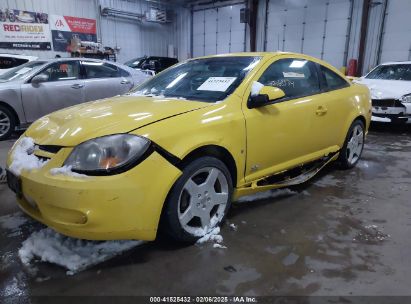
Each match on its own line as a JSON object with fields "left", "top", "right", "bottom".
{"left": 7, "top": 53, "right": 371, "bottom": 242}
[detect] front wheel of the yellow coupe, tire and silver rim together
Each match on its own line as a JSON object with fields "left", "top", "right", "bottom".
{"left": 162, "top": 156, "right": 233, "bottom": 243}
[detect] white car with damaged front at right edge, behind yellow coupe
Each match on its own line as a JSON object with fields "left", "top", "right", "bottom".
{"left": 355, "top": 61, "right": 411, "bottom": 123}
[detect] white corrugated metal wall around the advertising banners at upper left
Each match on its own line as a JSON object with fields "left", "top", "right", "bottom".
{"left": 0, "top": 0, "right": 175, "bottom": 62}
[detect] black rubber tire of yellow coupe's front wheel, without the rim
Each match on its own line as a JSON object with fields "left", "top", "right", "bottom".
{"left": 161, "top": 156, "right": 233, "bottom": 243}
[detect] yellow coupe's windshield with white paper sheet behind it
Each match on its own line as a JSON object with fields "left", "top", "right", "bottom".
{"left": 132, "top": 56, "right": 261, "bottom": 102}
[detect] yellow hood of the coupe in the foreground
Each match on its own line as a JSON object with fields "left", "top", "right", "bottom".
{"left": 26, "top": 95, "right": 211, "bottom": 147}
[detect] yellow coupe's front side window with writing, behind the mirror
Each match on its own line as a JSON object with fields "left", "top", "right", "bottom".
{"left": 258, "top": 58, "right": 320, "bottom": 98}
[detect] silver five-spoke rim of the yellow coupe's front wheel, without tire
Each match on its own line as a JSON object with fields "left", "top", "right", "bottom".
{"left": 178, "top": 167, "right": 229, "bottom": 236}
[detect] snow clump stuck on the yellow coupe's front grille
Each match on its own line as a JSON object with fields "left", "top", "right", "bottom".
{"left": 9, "top": 137, "right": 47, "bottom": 175}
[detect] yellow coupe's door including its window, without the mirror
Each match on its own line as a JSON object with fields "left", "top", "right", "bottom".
{"left": 243, "top": 58, "right": 320, "bottom": 182}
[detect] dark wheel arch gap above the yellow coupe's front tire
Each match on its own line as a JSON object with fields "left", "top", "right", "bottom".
{"left": 179, "top": 145, "right": 237, "bottom": 188}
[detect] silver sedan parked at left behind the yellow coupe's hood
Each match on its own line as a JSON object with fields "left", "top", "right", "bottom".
{"left": 0, "top": 58, "right": 149, "bottom": 140}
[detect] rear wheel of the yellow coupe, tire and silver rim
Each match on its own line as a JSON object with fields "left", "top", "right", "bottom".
{"left": 338, "top": 119, "right": 365, "bottom": 169}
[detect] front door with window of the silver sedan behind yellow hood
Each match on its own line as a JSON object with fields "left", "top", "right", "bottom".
{"left": 21, "top": 60, "right": 84, "bottom": 122}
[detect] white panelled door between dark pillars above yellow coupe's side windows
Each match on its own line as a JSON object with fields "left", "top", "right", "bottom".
{"left": 260, "top": 0, "right": 353, "bottom": 68}
